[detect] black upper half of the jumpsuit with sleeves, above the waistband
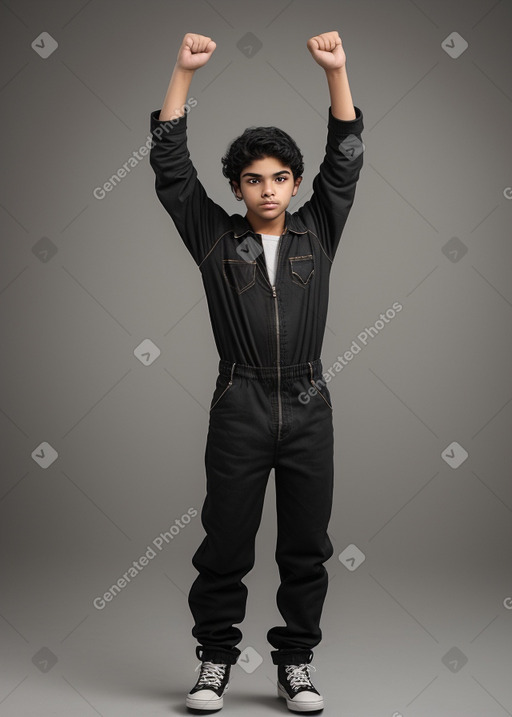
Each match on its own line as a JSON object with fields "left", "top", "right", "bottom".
{"left": 150, "top": 107, "right": 363, "bottom": 366}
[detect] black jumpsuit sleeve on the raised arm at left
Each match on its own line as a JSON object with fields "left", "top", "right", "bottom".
{"left": 149, "top": 110, "right": 228, "bottom": 265}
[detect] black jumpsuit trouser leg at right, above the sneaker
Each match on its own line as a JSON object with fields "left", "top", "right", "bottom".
{"left": 267, "top": 377, "right": 334, "bottom": 664}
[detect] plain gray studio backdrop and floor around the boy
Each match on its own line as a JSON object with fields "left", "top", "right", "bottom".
{"left": 0, "top": 0, "right": 512, "bottom": 717}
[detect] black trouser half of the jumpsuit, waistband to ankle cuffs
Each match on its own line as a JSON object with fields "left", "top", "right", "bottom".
{"left": 188, "top": 359, "right": 334, "bottom": 664}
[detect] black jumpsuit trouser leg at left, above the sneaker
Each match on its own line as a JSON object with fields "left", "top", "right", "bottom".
{"left": 188, "top": 375, "right": 274, "bottom": 659}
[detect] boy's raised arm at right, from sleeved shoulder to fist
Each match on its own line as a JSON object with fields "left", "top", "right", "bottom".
{"left": 298, "top": 32, "right": 363, "bottom": 260}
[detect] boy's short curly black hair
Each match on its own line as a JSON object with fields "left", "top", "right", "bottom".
{"left": 221, "top": 127, "right": 304, "bottom": 192}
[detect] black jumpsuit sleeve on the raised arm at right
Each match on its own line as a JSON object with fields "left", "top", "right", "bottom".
{"left": 297, "top": 107, "right": 363, "bottom": 261}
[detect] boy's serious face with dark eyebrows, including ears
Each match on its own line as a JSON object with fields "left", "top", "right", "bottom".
{"left": 233, "top": 157, "right": 302, "bottom": 226}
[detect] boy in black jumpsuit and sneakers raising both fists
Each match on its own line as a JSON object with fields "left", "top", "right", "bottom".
{"left": 150, "top": 32, "right": 363, "bottom": 712}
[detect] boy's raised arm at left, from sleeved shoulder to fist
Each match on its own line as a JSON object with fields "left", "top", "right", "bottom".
{"left": 149, "top": 33, "right": 227, "bottom": 265}
